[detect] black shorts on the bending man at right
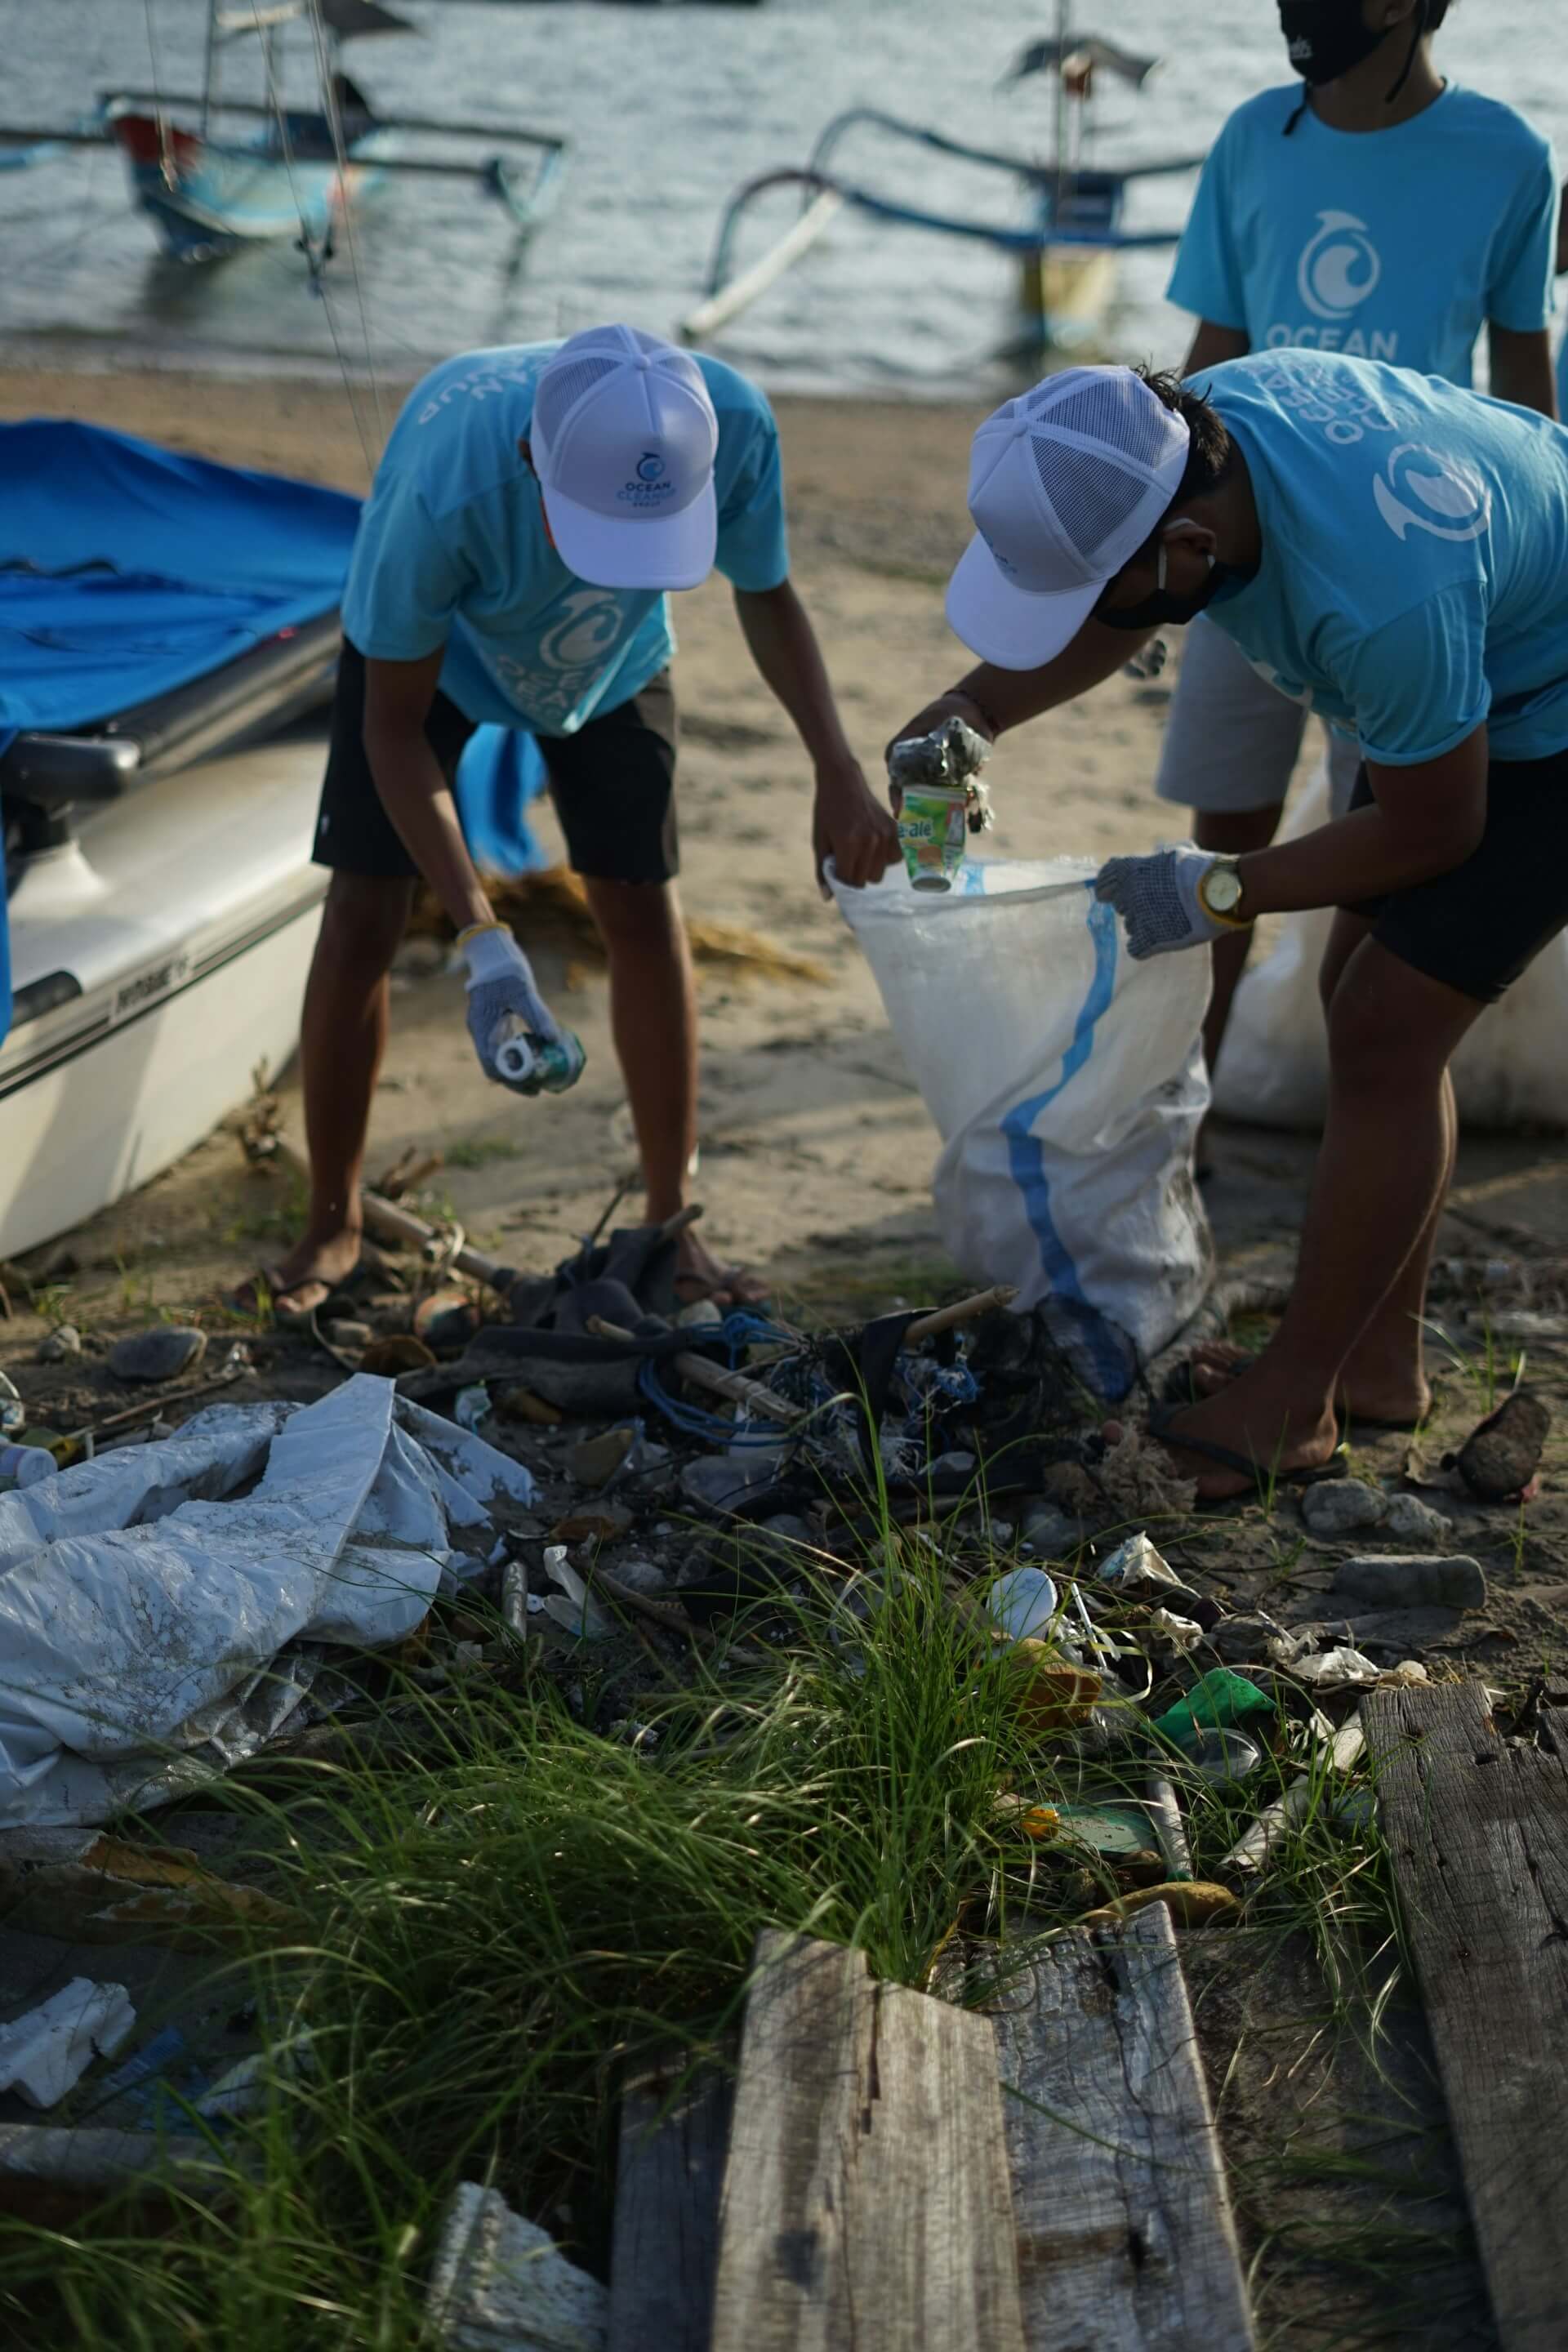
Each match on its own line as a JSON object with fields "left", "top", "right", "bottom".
{"left": 1345, "top": 751, "right": 1568, "bottom": 1004}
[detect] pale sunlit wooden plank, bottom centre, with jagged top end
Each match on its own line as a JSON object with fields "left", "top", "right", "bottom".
{"left": 712, "top": 1933, "right": 1025, "bottom": 2352}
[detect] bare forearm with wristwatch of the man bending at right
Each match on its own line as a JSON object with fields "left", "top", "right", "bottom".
{"left": 1236, "top": 727, "right": 1486, "bottom": 915}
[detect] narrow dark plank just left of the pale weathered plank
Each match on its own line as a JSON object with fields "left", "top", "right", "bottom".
{"left": 607, "top": 2063, "right": 733, "bottom": 2352}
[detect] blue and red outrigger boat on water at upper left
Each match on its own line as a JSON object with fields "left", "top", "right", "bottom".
{"left": 0, "top": 0, "right": 567, "bottom": 275}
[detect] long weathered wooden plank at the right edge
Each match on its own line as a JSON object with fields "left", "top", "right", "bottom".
{"left": 1361, "top": 1682, "right": 1568, "bottom": 2352}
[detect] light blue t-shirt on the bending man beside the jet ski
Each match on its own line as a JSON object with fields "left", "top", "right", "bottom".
{"left": 343, "top": 343, "right": 790, "bottom": 736}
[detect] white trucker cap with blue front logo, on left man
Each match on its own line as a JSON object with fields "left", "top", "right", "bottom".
{"left": 529, "top": 327, "right": 719, "bottom": 588}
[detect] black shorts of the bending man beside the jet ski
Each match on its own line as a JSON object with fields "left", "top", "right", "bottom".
{"left": 313, "top": 637, "right": 679, "bottom": 882}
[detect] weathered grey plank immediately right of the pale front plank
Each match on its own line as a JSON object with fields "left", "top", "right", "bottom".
{"left": 992, "top": 1905, "right": 1253, "bottom": 2352}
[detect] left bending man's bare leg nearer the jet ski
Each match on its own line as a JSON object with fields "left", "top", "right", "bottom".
{"left": 257, "top": 875, "right": 414, "bottom": 1315}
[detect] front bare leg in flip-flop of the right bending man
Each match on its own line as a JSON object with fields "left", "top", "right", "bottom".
{"left": 1142, "top": 938, "right": 1486, "bottom": 1500}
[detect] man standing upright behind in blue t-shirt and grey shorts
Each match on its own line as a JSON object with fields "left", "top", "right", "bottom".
{"left": 1154, "top": 0, "right": 1557, "bottom": 1096}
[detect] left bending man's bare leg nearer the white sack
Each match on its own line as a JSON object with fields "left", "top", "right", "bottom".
{"left": 583, "top": 875, "right": 766, "bottom": 1303}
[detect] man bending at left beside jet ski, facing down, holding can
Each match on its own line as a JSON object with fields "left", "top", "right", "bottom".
{"left": 265, "top": 327, "right": 898, "bottom": 1320}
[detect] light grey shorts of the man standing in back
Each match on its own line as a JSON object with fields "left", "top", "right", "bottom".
{"left": 1154, "top": 617, "right": 1361, "bottom": 816}
